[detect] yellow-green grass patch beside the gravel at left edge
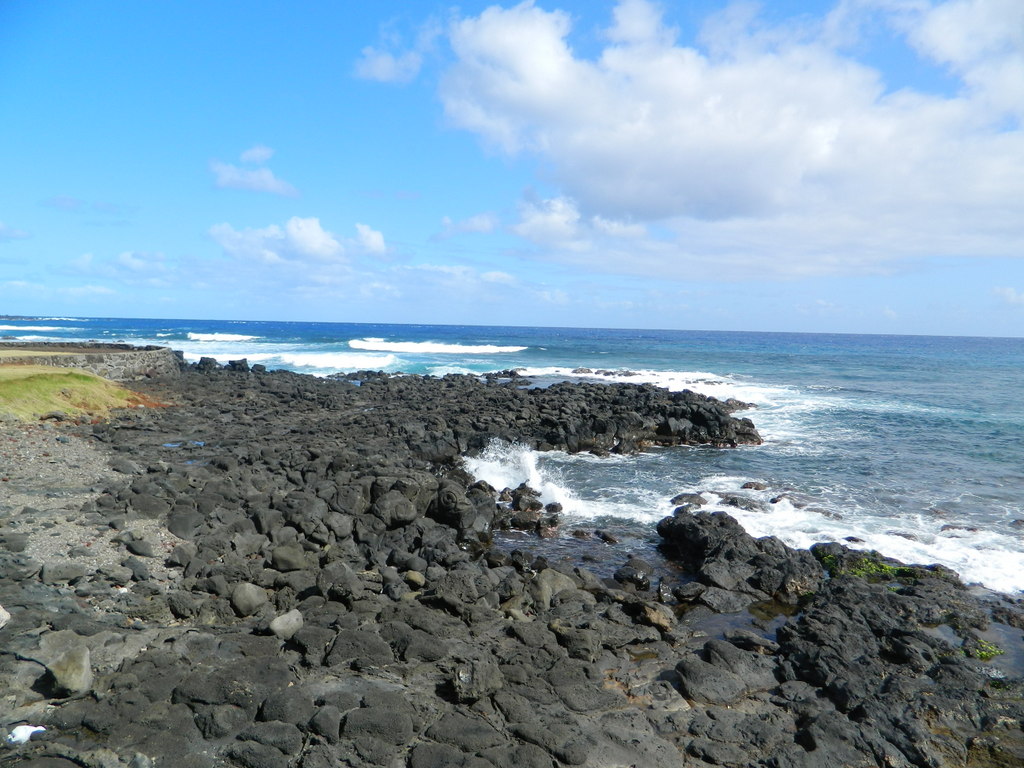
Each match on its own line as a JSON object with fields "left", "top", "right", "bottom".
{"left": 0, "top": 366, "right": 159, "bottom": 421}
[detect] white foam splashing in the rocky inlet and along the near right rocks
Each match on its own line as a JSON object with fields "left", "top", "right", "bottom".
{"left": 465, "top": 440, "right": 1024, "bottom": 593}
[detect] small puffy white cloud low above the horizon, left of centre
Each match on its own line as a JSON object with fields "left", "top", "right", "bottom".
{"left": 210, "top": 216, "right": 344, "bottom": 264}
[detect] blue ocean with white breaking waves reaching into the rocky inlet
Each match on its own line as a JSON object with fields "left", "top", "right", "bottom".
{"left": 8, "top": 317, "right": 1024, "bottom": 593}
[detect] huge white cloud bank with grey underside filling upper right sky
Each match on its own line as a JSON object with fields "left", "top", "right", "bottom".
{"left": 440, "top": 0, "right": 1024, "bottom": 275}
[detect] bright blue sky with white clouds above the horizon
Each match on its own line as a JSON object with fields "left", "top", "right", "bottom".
{"left": 0, "top": 0, "right": 1024, "bottom": 336}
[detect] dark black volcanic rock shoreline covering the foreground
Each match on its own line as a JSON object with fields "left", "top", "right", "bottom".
{"left": 0, "top": 360, "right": 1024, "bottom": 768}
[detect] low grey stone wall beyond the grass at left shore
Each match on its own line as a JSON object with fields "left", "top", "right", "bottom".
{"left": 0, "top": 342, "right": 180, "bottom": 381}
